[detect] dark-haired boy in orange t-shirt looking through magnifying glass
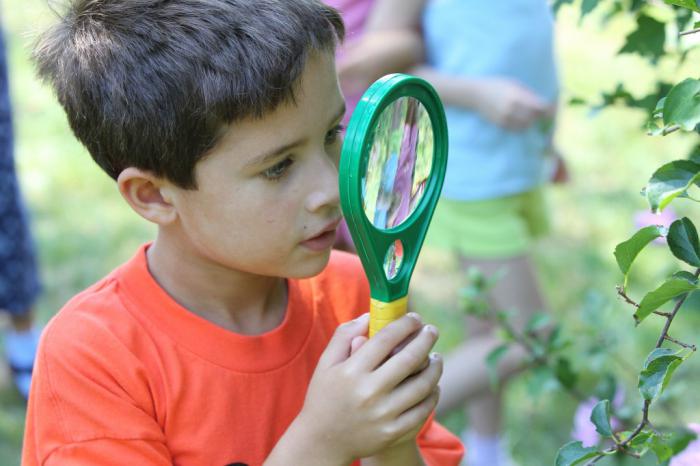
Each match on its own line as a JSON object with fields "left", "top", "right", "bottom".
{"left": 23, "top": 0, "right": 462, "bottom": 466}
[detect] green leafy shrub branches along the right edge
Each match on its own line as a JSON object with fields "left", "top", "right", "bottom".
{"left": 554, "top": 0, "right": 700, "bottom": 466}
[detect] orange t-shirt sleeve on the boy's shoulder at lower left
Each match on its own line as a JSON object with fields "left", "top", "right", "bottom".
{"left": 22, "top": 314, "right": 172, "bottom": 466}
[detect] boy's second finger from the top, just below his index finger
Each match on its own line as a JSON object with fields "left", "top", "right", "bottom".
{"left": 374, "top": 325, "right": 438, "bottom": 386}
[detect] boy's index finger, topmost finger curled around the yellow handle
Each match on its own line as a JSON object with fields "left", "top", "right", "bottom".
{"left": 355, "top": 312, "right": 422, "bottom": 371}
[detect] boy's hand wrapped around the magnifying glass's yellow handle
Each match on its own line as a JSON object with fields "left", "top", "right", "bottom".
{"left": 295, "top": 314, "right": 442, "bottom": 464}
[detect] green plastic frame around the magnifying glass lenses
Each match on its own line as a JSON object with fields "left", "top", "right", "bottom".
{"left": 339, "top": 74, "right": 448, "bottom": 302}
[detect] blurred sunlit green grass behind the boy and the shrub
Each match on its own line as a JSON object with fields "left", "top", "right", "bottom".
{"left": 0, "top": 0, "right": 700, "bottom": 466}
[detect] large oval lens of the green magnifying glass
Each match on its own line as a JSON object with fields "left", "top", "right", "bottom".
{"left": 362, "top": 97, "right": 433, "bottom": 229}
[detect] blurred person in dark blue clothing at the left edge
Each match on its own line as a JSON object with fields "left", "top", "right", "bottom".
{"left": 0, "top": 25, "right": 39, "bottom": 398}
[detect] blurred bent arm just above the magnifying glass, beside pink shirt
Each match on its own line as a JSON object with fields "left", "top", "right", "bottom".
{"left": 338, "top": 0, "right": 423, "bottom": 93}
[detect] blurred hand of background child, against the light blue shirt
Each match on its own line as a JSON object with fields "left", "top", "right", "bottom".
{"left": 476, "top": 78, "right": 554, "bottom": 131}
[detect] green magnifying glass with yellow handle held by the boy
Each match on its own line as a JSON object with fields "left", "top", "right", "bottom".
{"left": 340, "top": 74, "right": 447, "bottom": 337}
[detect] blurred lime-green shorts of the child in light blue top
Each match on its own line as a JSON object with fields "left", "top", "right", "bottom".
{"left": 425, "top": 189, "right": 549, "bottom": 259}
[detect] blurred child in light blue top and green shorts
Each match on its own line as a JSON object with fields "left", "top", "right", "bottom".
{"left": 406, "top": 0, "right": 565, "bottom": 466}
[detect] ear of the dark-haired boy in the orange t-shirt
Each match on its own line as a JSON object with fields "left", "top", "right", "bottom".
{"left": 117, "top": 167, "right": 177, "bottom": 226}
